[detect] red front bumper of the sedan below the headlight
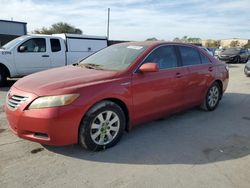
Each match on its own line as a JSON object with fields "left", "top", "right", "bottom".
{"left": 5, "top": 87, "right": 83, "bottom": 146}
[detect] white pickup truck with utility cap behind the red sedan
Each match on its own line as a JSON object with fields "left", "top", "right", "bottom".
{"left": 0, "top": 34, "right": 107, "bottom": 86}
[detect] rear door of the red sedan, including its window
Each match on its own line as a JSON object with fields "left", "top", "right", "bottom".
{"left": 178, "top": 46, "right": 216, "bottom": 106}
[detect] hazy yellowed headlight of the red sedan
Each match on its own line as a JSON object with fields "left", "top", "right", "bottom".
{"left": 29, "top": 94, "right": 79, "bottom": 109}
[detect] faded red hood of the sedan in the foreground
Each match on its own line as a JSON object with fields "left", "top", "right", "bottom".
{"left": 13, "top": 66, "right": 118, "bottom": 96}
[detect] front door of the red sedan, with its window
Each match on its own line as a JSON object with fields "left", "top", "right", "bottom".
{"left": 132, "top": 45, "right": 187, "bottom": 123}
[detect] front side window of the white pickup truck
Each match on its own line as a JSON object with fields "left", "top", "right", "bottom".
{"left": 18, "top": 38, "right": 46, "bottom": 53}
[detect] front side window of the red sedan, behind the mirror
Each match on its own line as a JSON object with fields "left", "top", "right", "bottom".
{"left": 144, "top": 46, "right": 178, "bottom": 69}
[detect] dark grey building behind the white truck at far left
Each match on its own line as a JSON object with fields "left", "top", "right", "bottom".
{"left": 0, "top": 20, "right": 27, "bottom": 46}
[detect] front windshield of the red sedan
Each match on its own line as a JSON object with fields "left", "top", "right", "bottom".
{"left": 79, "top": 45, "right": 147, "bottom": 71}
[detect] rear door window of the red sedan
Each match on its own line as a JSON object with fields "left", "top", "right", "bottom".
{"left": 179, "top": 46, "right": 201, "bottom": 66}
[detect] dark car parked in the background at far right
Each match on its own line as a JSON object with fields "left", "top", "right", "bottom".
{"left": 218, "top": 48, "right": 249, "bottom": 63}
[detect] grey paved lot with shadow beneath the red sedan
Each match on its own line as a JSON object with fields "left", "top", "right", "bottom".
{"left": 0, "top": 65, "right": 250, "bottom": 188}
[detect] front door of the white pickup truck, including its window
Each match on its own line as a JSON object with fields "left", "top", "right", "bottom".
{"left": 15, "top": 38, "right": 51, "bottom": 75}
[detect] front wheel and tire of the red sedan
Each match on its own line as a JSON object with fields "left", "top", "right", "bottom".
{"left": 78, "top": 100, "right": 126, "bottom": 151}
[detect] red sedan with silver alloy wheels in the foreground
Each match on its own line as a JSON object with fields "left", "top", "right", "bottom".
{"left": 5, "top": 42, "right": 228, "bottom": 150}
